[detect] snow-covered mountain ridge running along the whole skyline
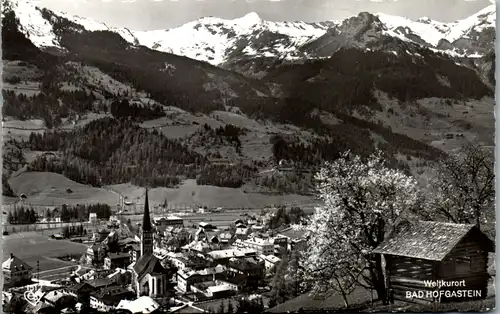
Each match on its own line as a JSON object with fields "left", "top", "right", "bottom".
{"left": 2, "top": 0, "right": 496, "bottom": 67}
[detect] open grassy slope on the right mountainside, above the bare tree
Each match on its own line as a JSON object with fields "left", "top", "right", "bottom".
{"left": 375, "top": 92, "right": 495, "bottom": 152}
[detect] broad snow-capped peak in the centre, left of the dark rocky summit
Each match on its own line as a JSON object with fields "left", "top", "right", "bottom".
{"left": 134, "top": 12, "right": 333, "bottom": 65}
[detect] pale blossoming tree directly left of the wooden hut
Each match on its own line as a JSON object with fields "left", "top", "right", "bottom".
{"left": 301, "top": 152, "right": 421, "bottom": 306}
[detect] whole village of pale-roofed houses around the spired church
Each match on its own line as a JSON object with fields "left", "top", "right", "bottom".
{"left": 2, "top": 193, "right": 306, "bottom": 313}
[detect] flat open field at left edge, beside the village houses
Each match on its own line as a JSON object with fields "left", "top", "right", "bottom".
{"left": 2, "top": 232, "right": 87, "bottom": 272}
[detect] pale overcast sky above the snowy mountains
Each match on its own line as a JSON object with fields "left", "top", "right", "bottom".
{"left": 37, "top": 0, "right": 493, "bottom": 30}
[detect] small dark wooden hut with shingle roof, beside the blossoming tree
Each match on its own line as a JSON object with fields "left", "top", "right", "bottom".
{"left": 373, "top": 221, "right": 494, "bottom": 303}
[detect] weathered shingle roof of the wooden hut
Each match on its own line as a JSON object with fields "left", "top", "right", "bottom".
{"left": 372, "top": 221, "right": 493, "bottom": 261}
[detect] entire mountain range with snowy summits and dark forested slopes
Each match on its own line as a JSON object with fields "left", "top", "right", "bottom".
{"left": 2, "top": 0, "right": 495, "bottom": 200}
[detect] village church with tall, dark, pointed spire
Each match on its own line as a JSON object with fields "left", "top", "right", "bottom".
{"left": 129, "top": 189, "right": 171, "bottom": 298}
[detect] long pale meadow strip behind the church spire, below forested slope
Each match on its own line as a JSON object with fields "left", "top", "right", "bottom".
{"left": 5, "top": 172, "right": 312, "bottom": 210}
